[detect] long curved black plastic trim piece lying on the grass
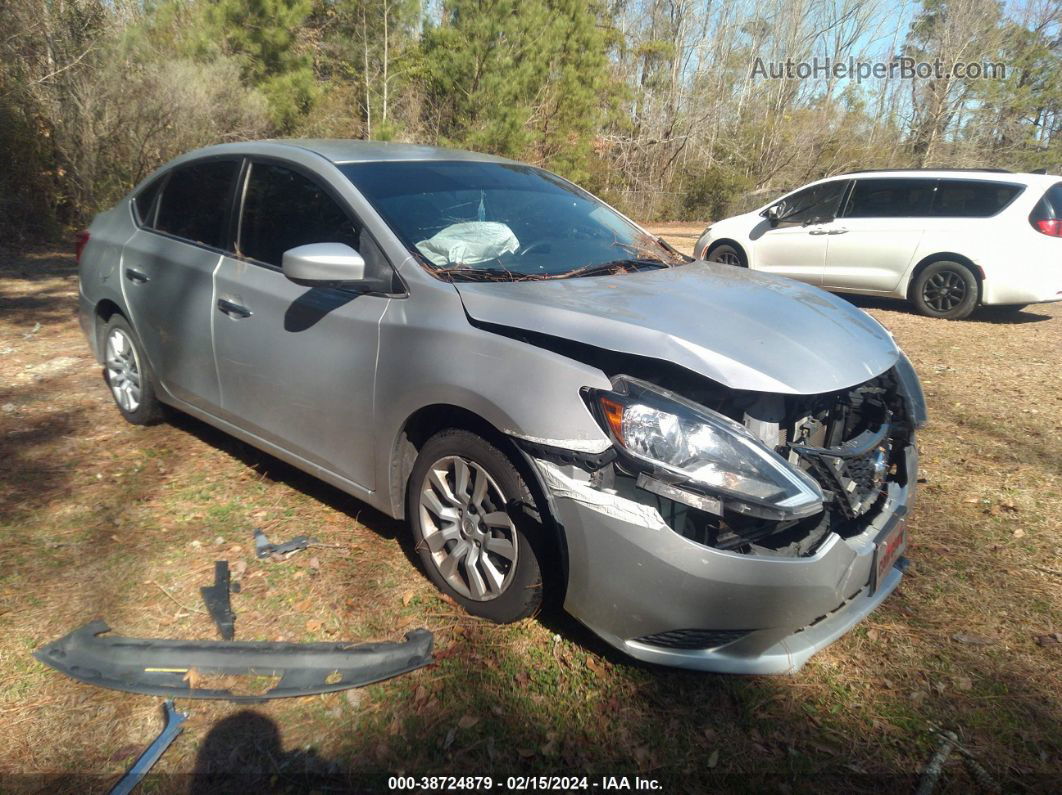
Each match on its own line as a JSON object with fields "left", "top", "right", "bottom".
{"left": 33, "top": 619, "right": 433, "bottom": 704}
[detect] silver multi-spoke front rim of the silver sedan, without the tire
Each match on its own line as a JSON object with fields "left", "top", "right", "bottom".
{"left": 419, "top": 455, "right": 518, "bottom": 602}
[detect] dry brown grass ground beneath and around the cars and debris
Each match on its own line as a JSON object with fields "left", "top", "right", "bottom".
{"left": 0, "top": 243, "right": 1062, "bottom": 791}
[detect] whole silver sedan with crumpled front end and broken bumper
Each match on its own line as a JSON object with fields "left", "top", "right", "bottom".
{"left": 79, "top": 141, "right": 925, "bottom": 673}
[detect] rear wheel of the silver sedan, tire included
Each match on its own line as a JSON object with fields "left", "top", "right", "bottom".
{"left": 100, "top": 314, "right": 166, "bottom": 426}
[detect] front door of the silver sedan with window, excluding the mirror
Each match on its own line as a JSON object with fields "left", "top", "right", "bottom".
{"left": 212, "top": 160, "right": 393, "bottom": 490}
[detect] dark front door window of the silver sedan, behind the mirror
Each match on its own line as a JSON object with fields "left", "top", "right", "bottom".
{"left": 239, "top": 162, "right": 361, "bottom": 267}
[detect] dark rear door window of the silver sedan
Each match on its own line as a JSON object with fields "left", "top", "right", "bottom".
{"left": 155, "top": 160, "right": 240, "bottom": 248}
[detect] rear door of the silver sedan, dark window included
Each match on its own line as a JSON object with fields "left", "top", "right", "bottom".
{"left": 121, "top": 159, "right": 240, "bottom": 410}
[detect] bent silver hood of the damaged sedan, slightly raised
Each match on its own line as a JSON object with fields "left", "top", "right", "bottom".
{"left": 455, "top": 262, "right": 900, "bottom": 395}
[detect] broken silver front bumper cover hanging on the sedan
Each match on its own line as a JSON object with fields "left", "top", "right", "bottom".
{"left": 537, "top": 447, "right": 918, "bottom": 674}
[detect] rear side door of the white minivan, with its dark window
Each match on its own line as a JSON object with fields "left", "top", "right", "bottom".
{"left": 823, "top": 177, "right": 937, "bottom": 292}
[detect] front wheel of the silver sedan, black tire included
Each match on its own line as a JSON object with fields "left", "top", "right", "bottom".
{"left": 406, "top": 430, "right": 545, "bottom": 624}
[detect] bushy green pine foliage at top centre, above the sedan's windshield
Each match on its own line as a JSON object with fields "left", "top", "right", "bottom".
{"left": 424, "top": 0, "right": 607, "bottom": 179}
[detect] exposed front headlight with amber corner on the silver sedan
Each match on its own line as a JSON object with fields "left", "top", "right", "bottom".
{"left": 594, "top": 376, "right": 823, "bottom": 518}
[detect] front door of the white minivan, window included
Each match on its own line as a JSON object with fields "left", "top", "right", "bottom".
{"left": 753, "top": 179, "right": 849, "bottom": 286}
